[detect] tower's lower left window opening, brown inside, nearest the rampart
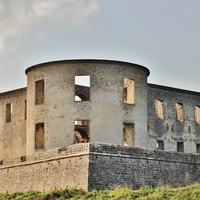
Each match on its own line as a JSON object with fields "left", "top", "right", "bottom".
{"left": 35, "top": 123, "right": 44, "bottom": 149}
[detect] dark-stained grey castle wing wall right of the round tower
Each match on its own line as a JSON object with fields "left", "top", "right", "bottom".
{"left": 148, "top": 84, "right": 200, "bottom": 153}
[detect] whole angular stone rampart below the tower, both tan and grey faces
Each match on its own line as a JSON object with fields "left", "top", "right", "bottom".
{"left": 0, "top": 143, "right": 200, "bottom": 192}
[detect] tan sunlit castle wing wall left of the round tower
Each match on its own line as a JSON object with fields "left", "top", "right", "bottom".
{"left": 0, "top": 88, "right": 26, "bottom": 160}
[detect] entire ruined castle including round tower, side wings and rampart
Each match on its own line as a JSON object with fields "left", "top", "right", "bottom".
{"left": 0, "top": 60, "right": 200, "bottom": 191}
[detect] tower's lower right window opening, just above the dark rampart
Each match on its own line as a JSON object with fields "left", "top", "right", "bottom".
{"left": 122, "top": 123, "right": 134, "bottom": 147}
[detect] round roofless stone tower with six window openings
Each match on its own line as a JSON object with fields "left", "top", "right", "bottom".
{"left": 26, "top": 60, "right": 149, "bottom": 154}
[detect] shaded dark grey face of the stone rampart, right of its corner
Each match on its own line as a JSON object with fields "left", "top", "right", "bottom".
{"left": 88, "top": 144, "right": 200, "bottom": 190}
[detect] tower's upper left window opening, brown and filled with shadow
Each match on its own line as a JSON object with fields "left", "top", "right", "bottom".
{"left": 35, "top": 80, "right": 44, "bottom": 105}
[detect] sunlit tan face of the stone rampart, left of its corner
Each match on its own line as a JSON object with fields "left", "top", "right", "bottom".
{"left": 0, "top": 144, "right": 89, "bottom": 192}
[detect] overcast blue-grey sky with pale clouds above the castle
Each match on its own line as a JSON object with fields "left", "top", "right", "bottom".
{"left": 0, "top": 0, "right": 200, "bottom": 92}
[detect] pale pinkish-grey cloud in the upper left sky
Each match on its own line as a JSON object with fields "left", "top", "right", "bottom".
{"left": 0, "top": 0, "right": 99, "bottom": 67}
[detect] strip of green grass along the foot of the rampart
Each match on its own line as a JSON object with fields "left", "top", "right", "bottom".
{"left": 0, "top": 183, "right": 200, "bottom": 200}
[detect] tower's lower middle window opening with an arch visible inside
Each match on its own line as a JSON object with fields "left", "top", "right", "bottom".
{"left": 74, "top": 120, "right": 90, "bottom": 144}
